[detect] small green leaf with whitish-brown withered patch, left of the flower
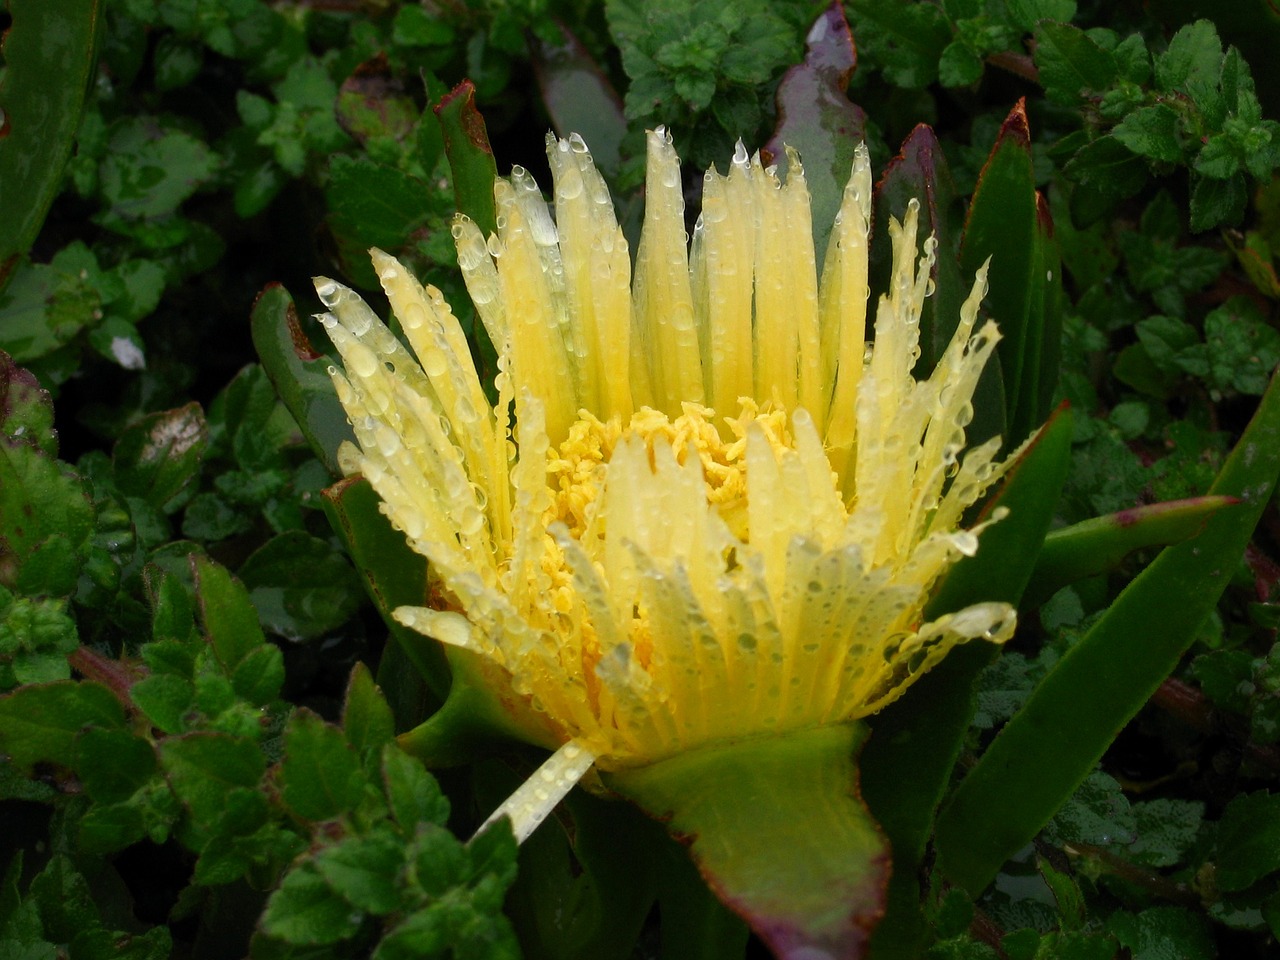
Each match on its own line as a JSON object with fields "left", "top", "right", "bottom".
{"left": 111, "top": 402, "right": 209, "bottom": 512}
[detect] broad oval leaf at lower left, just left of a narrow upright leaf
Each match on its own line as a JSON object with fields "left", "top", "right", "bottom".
{"left": 280, "top": 709, "right": 365, "bottom": 820}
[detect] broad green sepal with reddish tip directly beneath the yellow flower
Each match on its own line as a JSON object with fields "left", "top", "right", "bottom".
{"left": 607, "top": 724, "right": 888, "bottom": 960}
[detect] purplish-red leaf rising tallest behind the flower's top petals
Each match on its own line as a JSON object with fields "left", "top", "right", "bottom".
{"left": 760, "top": 0, "right": 867, "bottom": 266}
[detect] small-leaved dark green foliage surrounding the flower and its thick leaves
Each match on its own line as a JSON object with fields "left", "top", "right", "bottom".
{"left": 0, "top": 0, "right": 1280, "bottom": 960}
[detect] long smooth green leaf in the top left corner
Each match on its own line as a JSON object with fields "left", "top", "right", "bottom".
{"left": 0, "top": 0, "right": 104, "bottom": 289}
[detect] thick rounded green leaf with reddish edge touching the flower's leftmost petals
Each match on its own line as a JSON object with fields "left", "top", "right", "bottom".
{"left": 250, "top": 283, "right": 356, "bottom": 476}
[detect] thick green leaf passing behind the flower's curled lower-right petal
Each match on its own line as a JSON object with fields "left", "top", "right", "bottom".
{"left": 859, "top": 410, "right": 1073, "bottom": 959}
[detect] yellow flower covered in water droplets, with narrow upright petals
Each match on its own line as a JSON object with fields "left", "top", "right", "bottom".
{"left": 316, "top": 129, "right": 1015, "bottom": 833}
